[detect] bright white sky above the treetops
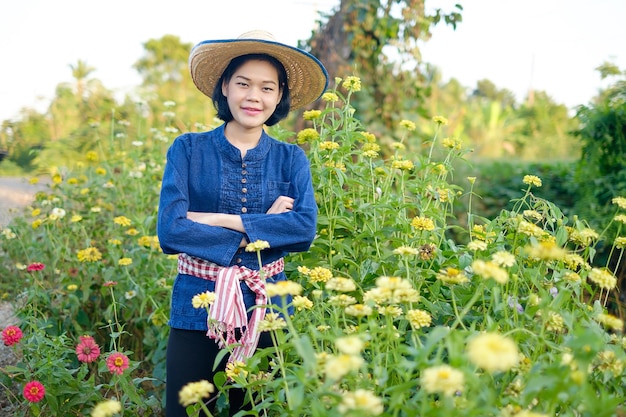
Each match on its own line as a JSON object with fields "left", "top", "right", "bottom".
{"left": 0, "top": 0, "right": 626, "bottom": 121}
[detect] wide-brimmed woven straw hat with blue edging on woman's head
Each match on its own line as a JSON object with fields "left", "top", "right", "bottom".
{"left": 189, "top": 30, "right": 328, "bottom": 110}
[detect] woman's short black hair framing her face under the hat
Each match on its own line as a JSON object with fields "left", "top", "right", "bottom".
{"left": 212, "top": 54, "right": 291, "bottom": 126}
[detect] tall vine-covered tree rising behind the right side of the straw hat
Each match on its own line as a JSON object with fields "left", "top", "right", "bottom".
{"left": 310, "top": 0, "right": 462, "bottom": 129}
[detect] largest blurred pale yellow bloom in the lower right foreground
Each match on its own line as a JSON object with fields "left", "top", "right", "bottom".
{"left": 467, "top": 333, "right": 520, "bottom": 372}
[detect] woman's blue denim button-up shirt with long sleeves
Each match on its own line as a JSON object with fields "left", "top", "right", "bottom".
{"left": 157, "top": 125, "right": 317, "bottom": 330}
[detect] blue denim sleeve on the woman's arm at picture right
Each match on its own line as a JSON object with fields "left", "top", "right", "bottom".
{"left": 241, "top": 145, "right": 317, "bottom": 252}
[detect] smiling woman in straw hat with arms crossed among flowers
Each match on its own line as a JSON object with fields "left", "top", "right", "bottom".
{"left": 157, "top": 31, "right": 328, "bottom": 417}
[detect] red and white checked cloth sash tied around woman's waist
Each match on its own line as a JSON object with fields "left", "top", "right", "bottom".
{"left": 178, "top": 253, "right": 285, "bottom": 362}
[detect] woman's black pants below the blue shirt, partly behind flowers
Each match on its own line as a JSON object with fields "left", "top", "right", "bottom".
{"left": 165, "top": 329, "right": 272, "bottom": 417}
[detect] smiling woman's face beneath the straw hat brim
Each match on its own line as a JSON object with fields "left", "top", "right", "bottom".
{"left": 222, "top": 60, "right": 282, "bottom": 128}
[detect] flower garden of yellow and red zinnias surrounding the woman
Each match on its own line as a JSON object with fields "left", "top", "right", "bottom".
{"left": 0, "top": 77, "right": 626, "bottom": 417}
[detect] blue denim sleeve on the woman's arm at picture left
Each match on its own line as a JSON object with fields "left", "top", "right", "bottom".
{"left": 157, "top": 135, "right": 244, "bottom": 265}
